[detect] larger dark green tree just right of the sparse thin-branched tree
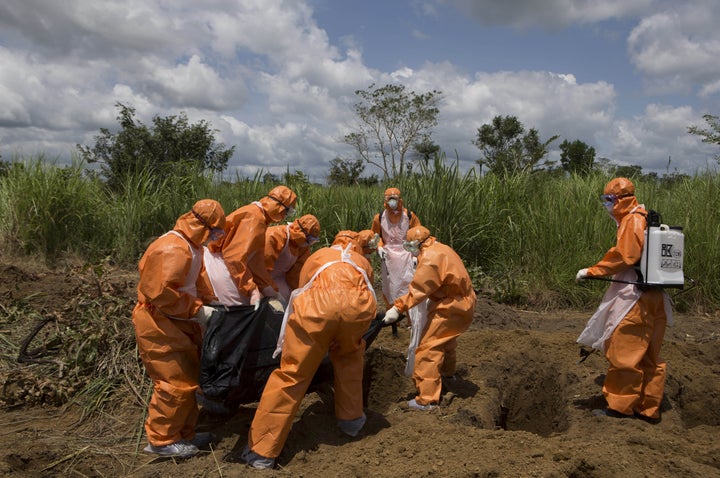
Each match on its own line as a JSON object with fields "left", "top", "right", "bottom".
{"left": 473, "top": 115, "right": 558, "bottom": 176}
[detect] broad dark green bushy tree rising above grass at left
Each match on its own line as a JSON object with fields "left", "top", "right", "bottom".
{"left": 77, "top": 103, "right": 235, "bottom": 190}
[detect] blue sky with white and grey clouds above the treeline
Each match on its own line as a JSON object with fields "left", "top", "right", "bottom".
{"left": 0, "top": 0, "right": 720, "bottom": 181}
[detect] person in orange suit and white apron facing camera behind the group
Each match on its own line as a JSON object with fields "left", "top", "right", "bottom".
{"left": 370, "top": 188, "right": 420, "bottom": 306}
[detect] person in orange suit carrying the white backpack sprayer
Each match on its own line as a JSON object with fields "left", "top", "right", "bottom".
{"left": 575, "top": 178, "right": 672, "bottom": 422}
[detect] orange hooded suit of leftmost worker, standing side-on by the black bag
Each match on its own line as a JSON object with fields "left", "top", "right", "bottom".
{"left": 132, "top": 199, "right": 225, "bottom": 446}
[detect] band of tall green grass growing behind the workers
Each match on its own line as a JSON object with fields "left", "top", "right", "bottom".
{"left": 0, "top": 157, "right": 720, "bottom": 308}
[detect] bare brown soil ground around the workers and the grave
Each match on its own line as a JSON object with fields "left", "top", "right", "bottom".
{"left": 0, "top": 261, "right": 720, "bottom": 478}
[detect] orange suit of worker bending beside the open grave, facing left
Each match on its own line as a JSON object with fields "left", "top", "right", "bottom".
{"left": 394, "top": 226, "right": 476, "bottom": 405}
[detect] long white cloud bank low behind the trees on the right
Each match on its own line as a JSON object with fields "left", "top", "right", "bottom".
{"left": 390, "top": 63, "right": 712, "bottom": 173}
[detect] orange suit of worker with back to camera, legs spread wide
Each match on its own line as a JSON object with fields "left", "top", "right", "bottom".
{"left": 248, "top": 231, "right": 377, "bottom": 458}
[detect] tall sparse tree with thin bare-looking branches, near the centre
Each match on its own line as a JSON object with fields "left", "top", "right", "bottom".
{"left": 343, "top": 84, "right": 442, "bottom": 179}
